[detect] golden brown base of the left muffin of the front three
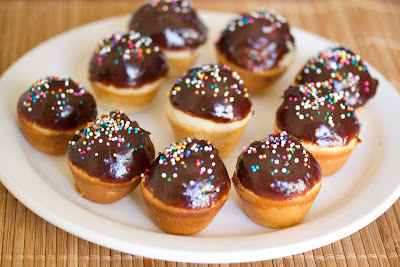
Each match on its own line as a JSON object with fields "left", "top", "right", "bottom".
{"left": 67, "top": 156, "right": 140, "bottom": 204}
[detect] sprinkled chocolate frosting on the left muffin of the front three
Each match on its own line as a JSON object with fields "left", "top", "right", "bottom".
{"left": 67, "top": 110, "right": 155, "bottom": 182}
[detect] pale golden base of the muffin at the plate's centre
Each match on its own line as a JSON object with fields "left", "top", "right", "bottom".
{"left": 165, "top": 98, "right": 252, "bottom": 157}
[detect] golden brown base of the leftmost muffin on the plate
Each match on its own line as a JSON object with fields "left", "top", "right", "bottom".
{"left": 18, "top": 115, "right": 86, "bottom": 154}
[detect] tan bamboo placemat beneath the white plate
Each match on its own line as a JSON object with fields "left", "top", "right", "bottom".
{"left": 0, "top": 0, "right": 400, "bottom": 266}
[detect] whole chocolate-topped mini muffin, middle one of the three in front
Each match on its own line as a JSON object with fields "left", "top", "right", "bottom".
{"left": 140, "top": 138, "right": 231, "bottom": 235}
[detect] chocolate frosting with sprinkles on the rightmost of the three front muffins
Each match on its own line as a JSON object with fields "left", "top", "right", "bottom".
{"left": 236, "top": 132, "right": 322, "bottom": 200}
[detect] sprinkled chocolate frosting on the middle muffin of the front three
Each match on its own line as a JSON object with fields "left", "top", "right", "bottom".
{"left": 142, "top": 138, "right": 231, "bottom": 209}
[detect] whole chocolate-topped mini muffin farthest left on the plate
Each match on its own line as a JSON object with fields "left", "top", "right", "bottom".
{"left": 17, "top": 76, "right": 97, "bottom": 154}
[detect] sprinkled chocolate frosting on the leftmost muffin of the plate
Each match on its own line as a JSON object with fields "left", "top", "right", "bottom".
{"left": 17, "top": 76, "right": 97, "bottom": 130}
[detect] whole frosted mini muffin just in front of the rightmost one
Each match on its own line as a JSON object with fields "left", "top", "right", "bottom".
{"left": 275, "top": 82, "right": 360, "bottom": 176}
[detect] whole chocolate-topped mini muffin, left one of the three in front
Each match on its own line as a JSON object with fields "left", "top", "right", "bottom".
{"left": 67, "top": 110, "right": 155, "bottom": 204}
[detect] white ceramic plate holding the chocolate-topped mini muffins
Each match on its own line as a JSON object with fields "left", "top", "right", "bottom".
{"left": 0, "top": 12, "right": 400, "bottom": 263}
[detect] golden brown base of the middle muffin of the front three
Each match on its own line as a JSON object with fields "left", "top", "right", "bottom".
{"left": 140, "top": 182, "right": 229, "bottom": 235}
